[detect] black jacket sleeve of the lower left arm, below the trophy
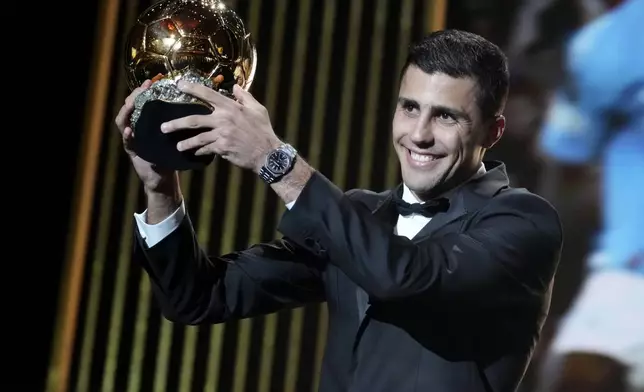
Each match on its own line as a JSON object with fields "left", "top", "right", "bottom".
{"left": 133, "top": 215, "right": 325, "bottom": 325}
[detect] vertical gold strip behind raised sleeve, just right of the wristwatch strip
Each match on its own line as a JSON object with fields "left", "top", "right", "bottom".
{"left": 309, "top": 0, "right": 337, "bottom": 391}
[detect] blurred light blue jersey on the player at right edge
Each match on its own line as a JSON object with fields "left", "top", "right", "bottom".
{"left": 541, "top": 0, "right": 644, "bottom": 274}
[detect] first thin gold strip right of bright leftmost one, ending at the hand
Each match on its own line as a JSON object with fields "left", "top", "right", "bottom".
{"left": 76, "top": 134, "right": 123, "bottom": 391}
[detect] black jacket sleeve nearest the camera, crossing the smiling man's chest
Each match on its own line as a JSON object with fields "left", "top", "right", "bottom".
{"left": 279, "top": 173, "right": 562, "bottom": 306}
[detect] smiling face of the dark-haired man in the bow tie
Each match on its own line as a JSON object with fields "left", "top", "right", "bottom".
{"left": 393, "top": 65, "right": 503, "bottom": 200}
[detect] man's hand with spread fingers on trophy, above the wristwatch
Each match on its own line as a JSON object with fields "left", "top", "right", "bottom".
{"left": 161, "top": 81, "right": 281, "bottom": 173}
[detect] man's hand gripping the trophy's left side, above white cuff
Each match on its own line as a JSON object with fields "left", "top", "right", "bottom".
{"left": 114, "top": 80, "right": 182, "bottom": 220}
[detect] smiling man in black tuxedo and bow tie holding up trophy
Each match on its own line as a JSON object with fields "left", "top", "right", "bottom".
{"left": 116, "top": 31, "right": 562, "bottom": 392}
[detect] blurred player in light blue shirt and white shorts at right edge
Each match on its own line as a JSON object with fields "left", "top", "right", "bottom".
{"left": 541, "top": 0, "right": 644, "bottom": 392}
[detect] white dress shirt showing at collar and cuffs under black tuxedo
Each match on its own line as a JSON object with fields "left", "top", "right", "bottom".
{"left": 134, "top": 163, "right": 485, "bottom": 247}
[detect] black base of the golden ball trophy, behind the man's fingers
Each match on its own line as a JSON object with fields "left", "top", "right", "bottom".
{"left": 133, "top": 100, "right": 215, "bottom": 171}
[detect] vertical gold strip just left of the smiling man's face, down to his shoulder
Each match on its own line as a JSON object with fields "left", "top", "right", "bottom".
{"left": 358, "top": 0, "right": 392, "bottom": 188}
